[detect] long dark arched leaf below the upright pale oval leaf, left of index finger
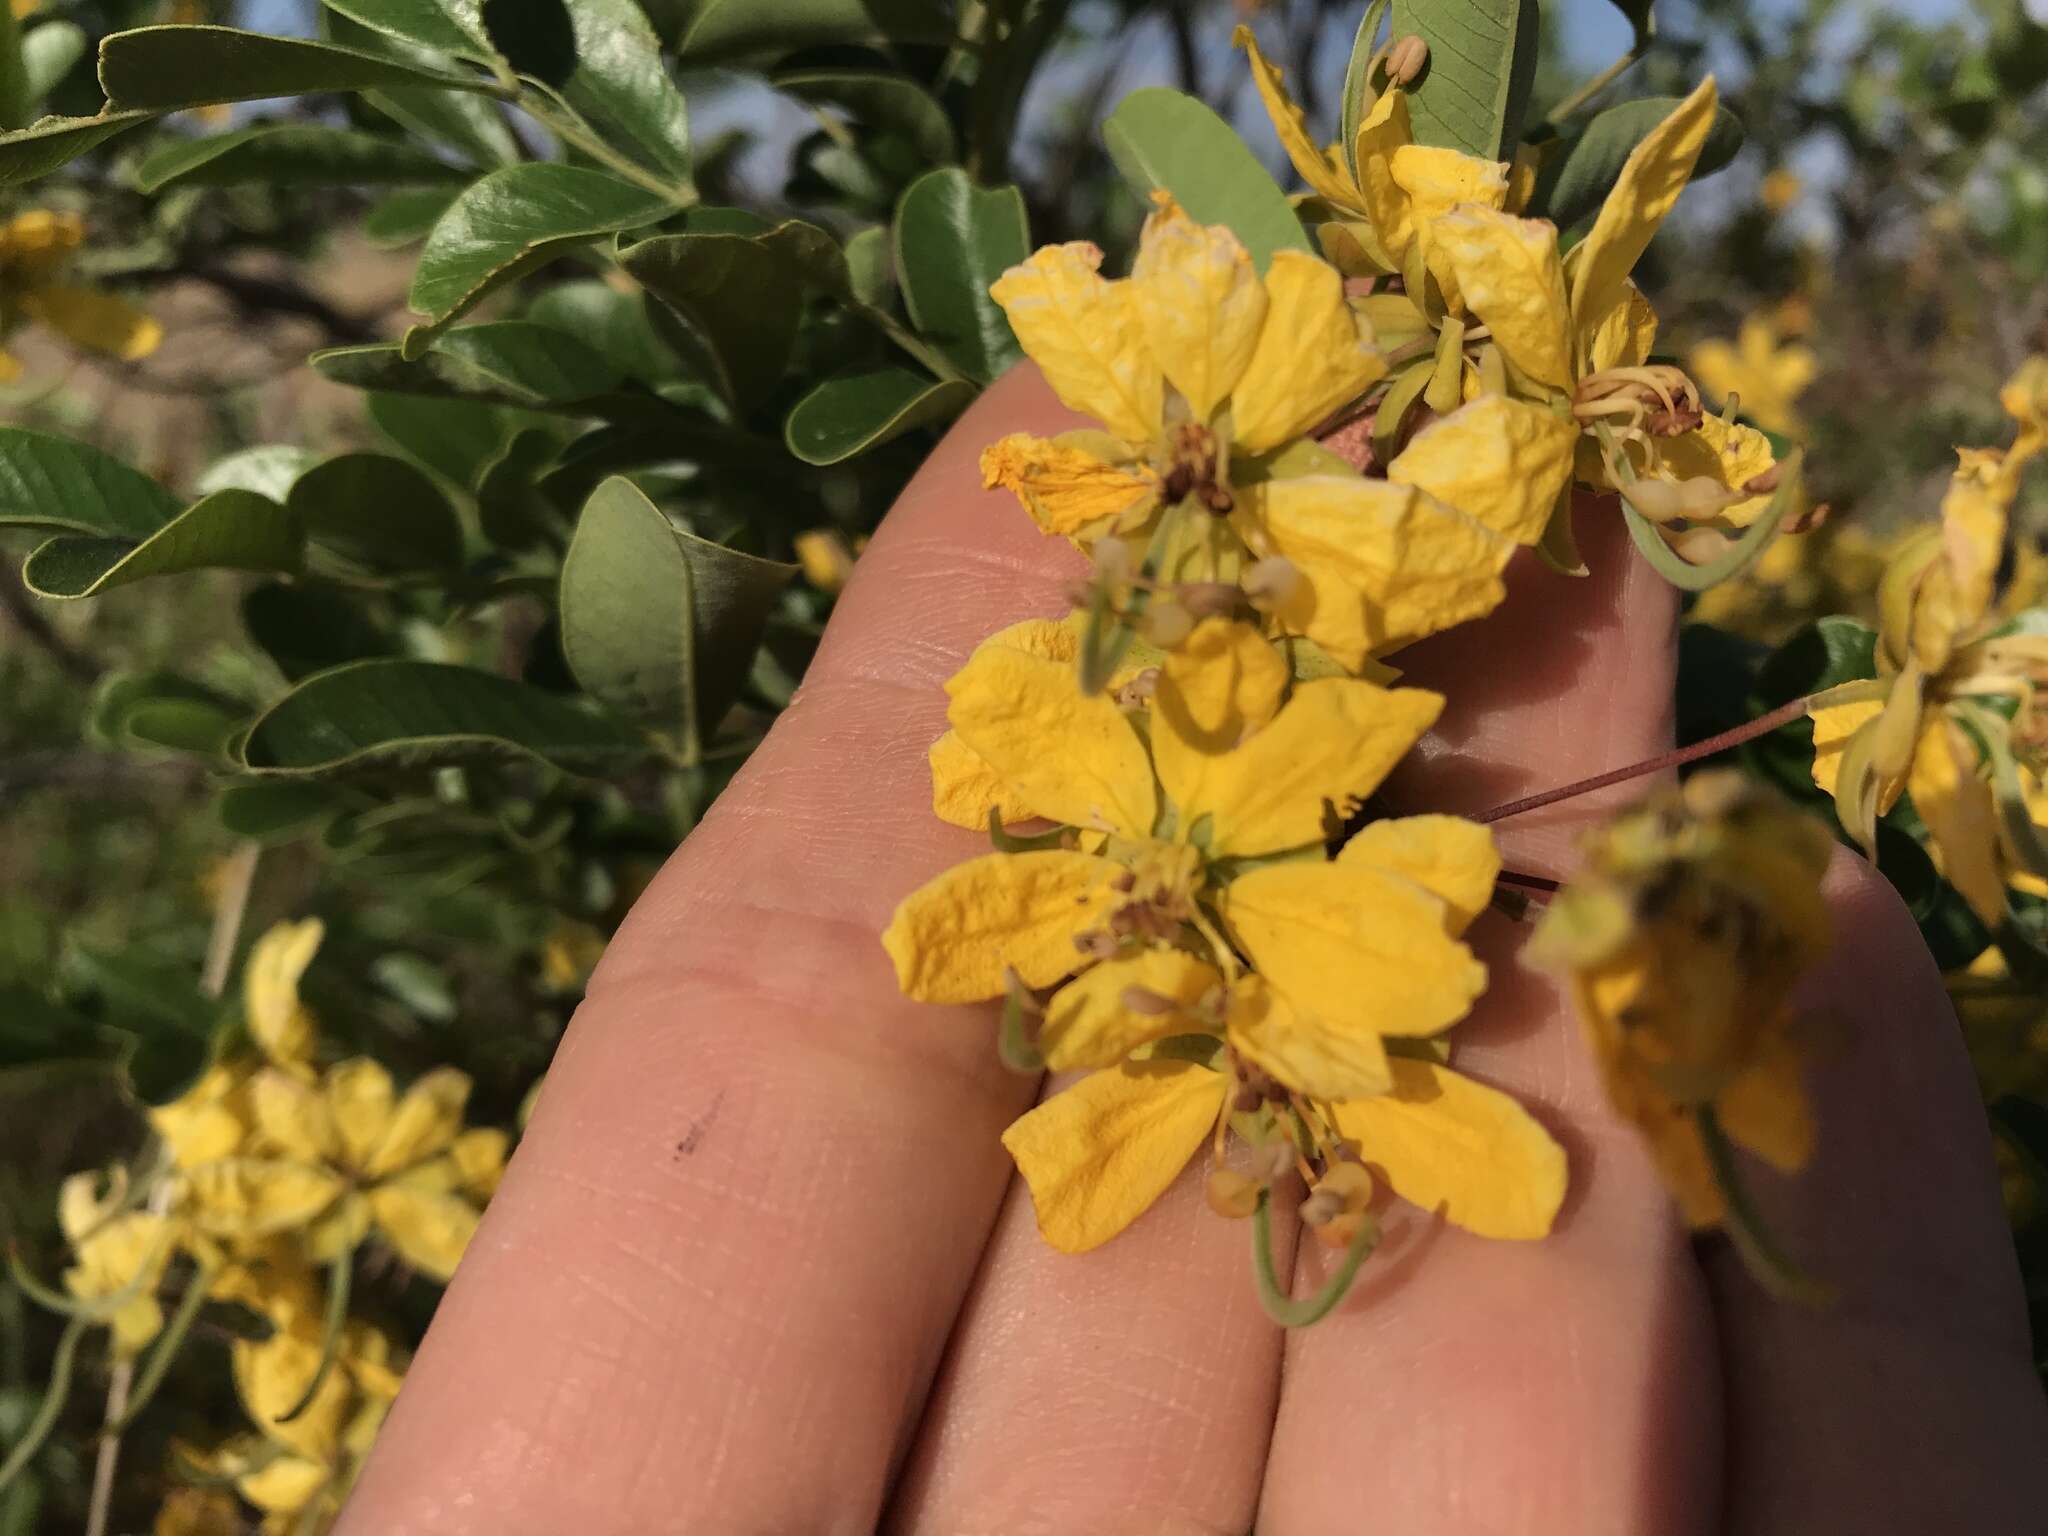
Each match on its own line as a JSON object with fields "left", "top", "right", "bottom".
{"left": 242, "top": 659, "right": 645, "bottom": 776}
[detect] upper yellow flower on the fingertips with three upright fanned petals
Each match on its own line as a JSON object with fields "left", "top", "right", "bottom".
{"left": 981, "top": 201, "right": 1571, "bottom": 672}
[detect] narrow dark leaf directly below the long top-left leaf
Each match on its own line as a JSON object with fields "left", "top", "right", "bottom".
{"left": 135, "top": 123, "right": 469, "bottom": 193}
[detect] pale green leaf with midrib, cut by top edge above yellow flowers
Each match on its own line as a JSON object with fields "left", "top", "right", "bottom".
{"left": 1393, "top": 0, "right": 1542, "bottom": 160}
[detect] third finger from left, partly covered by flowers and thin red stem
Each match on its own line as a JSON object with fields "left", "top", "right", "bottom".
{"left": 1260, "top": 508, "right": 1718, "bottom": 1536}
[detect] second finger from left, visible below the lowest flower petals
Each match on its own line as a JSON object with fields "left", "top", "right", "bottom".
{"left": 887, "top": 1097, "right": 1290, "bottom": 1536}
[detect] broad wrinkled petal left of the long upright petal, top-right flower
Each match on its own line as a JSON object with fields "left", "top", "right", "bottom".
{"left": 1430, "top": 207, "right": 1573, "bottom": 389}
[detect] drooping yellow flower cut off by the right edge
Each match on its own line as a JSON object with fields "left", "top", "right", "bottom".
{"left": 1812, "top": 358, "right": 2048, "bottom": 926}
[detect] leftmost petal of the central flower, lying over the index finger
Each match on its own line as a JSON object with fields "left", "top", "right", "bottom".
{"left": 883, "top": 848, "right": 1122, "bottom": 1004}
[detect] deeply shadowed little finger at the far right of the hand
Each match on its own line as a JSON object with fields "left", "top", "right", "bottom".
{"left": 1708, "top": 852, "right": 2048, "bottom": 1536}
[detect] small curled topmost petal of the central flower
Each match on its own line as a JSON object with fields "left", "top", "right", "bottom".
{"left": 1151, "top": 618, "right": 1290, "bottom": 809}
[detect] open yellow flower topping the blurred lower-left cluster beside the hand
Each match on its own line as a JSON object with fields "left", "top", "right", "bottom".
{"left": 186, "top": 1057, "right": 504, "bottom": 1280}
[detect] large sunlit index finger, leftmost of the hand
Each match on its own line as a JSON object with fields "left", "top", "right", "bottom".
{"left": 342, "top": 375, "right": 1075, "bottom": 1536}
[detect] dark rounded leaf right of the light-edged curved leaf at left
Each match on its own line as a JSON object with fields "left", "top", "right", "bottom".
{"left": 287, "top": 453, "right": 463, "bottom": 573}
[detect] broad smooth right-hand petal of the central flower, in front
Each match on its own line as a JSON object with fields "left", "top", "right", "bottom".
{"left": 1217, "top": 860, "right": 1487, "bottom": 1040}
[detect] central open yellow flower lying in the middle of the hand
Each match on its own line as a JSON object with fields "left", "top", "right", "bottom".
{"left": 883, "top": 618, "right": 1499, "bottom": 1122}
